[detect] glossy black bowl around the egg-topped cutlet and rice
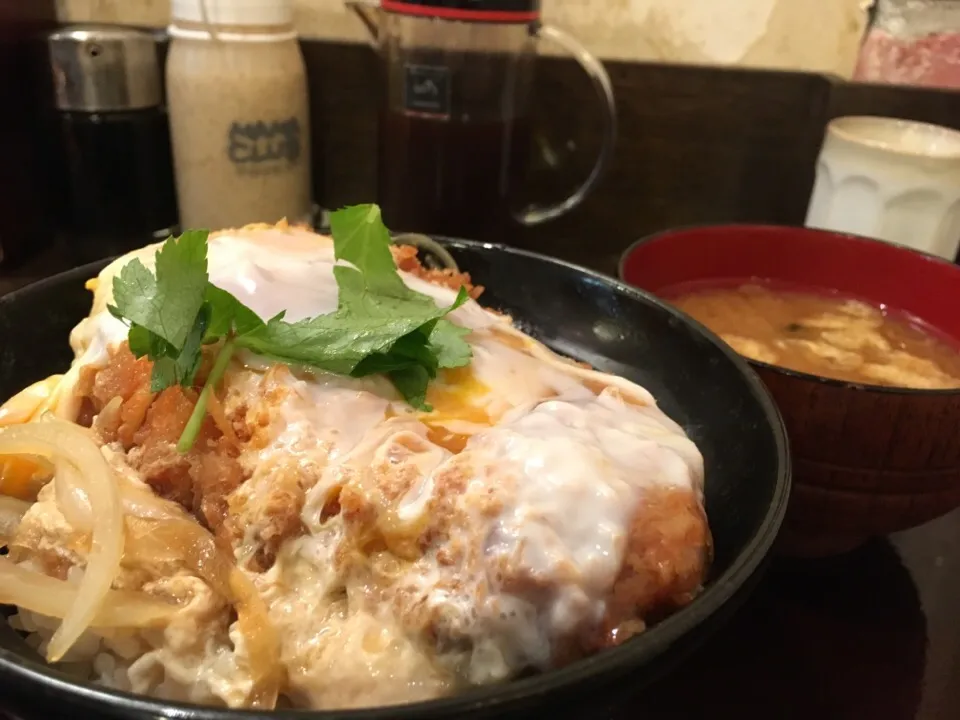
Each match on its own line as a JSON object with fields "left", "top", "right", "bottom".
{"left": 0, "top": 241, "right": 790, "bottom": 720}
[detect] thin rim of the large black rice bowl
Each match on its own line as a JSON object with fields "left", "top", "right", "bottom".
{"left": 0, "top": 235, "right": 792, "bottom": 720}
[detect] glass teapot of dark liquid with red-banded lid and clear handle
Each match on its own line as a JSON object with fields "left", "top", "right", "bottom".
{"left": 347, "top": 0, "right": 617, "bottom": 240}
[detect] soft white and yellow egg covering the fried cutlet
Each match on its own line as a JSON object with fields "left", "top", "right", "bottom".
{"left": 0, "top": 228, "right": 709, "bottom": 708}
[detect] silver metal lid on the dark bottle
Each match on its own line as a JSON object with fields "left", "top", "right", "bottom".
{"left": 47, "top": 25, "right": 163, "bottom": 112}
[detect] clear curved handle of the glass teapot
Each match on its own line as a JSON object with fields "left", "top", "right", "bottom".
{"left": 517, "top": 25, "right": 617, "bottom": 226}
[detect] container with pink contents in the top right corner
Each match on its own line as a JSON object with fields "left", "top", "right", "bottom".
{"left": 854, "top": 0, "right": 960, "bottom": 89}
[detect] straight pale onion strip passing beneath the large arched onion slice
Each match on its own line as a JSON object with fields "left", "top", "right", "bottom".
{"left": 0, "top": 557, "right": 179, "bottom": 628}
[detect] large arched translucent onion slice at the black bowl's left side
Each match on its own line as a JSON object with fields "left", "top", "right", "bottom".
{"left": 0, "top": 418, "right": 124, "bottom": 662}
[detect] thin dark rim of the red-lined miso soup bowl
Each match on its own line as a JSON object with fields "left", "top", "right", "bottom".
{"left": 617, "top": 222, "right": 960, "bottom": 397}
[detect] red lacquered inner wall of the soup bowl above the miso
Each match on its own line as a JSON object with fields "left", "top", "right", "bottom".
{"left": 620, "top": 225, "right": 960, "bottom": 339}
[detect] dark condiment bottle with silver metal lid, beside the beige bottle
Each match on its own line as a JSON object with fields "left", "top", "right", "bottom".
{"left": 48, "top": 26, "right": 178, "bottom": 262}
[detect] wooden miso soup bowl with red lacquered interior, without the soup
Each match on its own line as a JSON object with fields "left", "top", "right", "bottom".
{"left": 620, "top": 225, "right": 960, "bottom": 555}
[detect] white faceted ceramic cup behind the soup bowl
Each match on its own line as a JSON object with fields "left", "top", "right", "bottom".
{"left": 806, "top": 117, "right": 960, "bottom": 261}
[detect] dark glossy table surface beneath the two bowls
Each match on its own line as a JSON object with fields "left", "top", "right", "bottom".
{"left": 0, "top": 251, "right": 960, "bottom": 720}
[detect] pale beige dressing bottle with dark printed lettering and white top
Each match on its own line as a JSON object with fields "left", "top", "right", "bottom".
{"left": 167, "top": 0, "right": 312, "bottom": 230}
